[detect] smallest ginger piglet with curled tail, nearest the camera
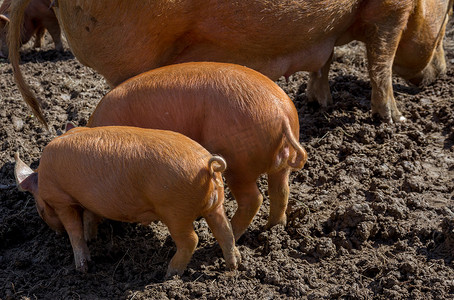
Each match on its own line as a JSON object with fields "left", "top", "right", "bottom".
{"left": 15, "top": 126, "right": 241, "bottom": 277}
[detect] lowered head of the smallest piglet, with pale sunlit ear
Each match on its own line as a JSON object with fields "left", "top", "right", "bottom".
{"left": 14, "top": 153, "right": 64, "bottom": 232}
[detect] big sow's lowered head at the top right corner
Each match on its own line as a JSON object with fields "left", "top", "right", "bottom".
{"left": 393, "top": 0, "right": 453, "bottom": 86}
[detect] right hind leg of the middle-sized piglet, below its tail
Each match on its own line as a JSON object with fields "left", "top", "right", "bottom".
{"left": 266, "top": 169, "right": 290, "bottom": 229}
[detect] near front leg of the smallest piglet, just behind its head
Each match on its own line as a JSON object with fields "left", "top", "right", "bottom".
{"left": 56, "top": 207, "right": 91, "bottom": 273}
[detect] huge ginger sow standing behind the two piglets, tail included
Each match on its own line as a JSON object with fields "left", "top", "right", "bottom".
{"left": 10, "top": 0, "right": 454, "bottom": 125}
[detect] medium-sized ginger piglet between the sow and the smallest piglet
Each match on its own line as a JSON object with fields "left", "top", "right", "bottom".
{"left": 87, "top": 62, "right": 307, "bottom": 240}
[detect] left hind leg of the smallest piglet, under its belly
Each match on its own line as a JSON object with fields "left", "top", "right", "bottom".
{"left": 164, "top": 218, "right": 199, "bottom": 278}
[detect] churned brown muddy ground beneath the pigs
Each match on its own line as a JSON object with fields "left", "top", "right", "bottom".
{"left": 0, "top": 22, "right": 454, "bottom": 299}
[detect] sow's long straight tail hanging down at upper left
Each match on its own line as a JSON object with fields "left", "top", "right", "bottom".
{"left": 8, "top": 0, "right": 48, "bottom": 129}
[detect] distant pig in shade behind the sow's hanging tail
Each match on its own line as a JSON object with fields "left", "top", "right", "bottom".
{"left": 0, "top": 0, "right": 63, "bottom": 58}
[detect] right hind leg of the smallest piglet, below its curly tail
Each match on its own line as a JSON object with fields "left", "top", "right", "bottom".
{"left": 203, "top": 205, "right": 241, "bottom": 270}
